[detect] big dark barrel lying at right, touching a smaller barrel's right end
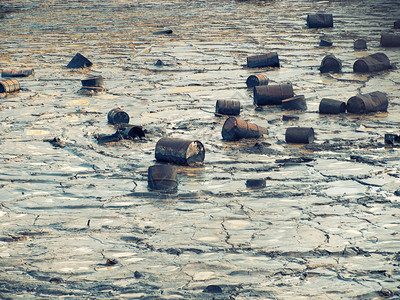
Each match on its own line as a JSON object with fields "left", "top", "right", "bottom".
{"left": 347, "top": 91, "right": 389, "bottom": 114}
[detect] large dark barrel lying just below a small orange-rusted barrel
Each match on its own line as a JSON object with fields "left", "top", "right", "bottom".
{"left": 253, "top": 83, "right": 294, "bottom": 106}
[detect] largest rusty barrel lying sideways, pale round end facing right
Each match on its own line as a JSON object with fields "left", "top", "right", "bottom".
{"left": 155, "top": 137, "right": 205, "bottom": 166}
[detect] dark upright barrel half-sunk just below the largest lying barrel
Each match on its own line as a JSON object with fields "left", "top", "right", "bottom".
{"left": 147, "top": 165, "right": 178, "bottom": 191}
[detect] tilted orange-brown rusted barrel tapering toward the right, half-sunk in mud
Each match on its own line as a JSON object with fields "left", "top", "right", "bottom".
{"left": 221, "top": 117, "right": 268, "bottom": 141}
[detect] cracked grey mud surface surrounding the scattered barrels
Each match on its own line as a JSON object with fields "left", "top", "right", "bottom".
{"left": 0, "top": 0, "right": 400, "bottom": 299}
